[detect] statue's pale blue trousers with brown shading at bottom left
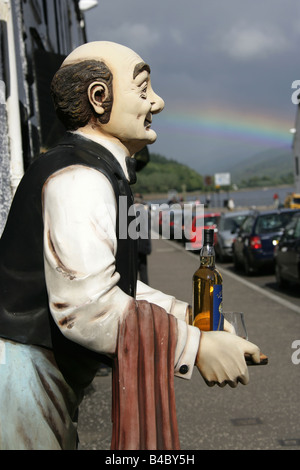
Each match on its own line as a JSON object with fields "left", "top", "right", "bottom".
{"left": 0, "top": 338, "right": 78, "bottom": 450}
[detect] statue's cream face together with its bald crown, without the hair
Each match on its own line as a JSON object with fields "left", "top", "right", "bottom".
{"left": 66, "top": 42, "right": 164, "bottom": 154}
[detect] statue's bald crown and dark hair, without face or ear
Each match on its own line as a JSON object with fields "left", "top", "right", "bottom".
{"left": 51, "top": 41, "right": 150, "bottom": 130}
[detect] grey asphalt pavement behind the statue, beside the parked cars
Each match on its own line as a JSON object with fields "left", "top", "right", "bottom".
{"left": 78, "top": 239, "right": 300, "bottom": 451}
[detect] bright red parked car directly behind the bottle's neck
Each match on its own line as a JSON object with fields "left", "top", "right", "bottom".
{"left": 187, "top": 212, "right": 221, "bottom": 251}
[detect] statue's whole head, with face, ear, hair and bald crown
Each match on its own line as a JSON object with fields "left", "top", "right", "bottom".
{"left": 52, "top": 41, "right": 164, "bottom": 153}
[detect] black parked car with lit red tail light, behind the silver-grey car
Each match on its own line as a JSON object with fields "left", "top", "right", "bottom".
{"left": 233, "top": 209, "right": 297, "bottom": 274}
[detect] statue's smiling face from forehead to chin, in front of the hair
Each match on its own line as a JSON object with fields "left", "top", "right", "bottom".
{"left": 102, "top": 50, "right": 164, "bottom": 151}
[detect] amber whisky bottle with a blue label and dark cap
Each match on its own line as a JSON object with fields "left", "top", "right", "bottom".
{"left": 192, "top": 229, "right": 223, "bottom": 331}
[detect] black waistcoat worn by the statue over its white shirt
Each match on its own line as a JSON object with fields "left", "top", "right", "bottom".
{"left": 0, "top": 133, "right": 137, "bottom": 388}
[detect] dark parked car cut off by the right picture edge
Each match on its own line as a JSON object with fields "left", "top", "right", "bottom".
{"left": 274, "top": 212, "right": 300, "bottom": 288}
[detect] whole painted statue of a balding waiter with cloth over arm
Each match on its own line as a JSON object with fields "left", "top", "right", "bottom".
{"left": 0, "top": 42, "right": 259, "bottom": 449}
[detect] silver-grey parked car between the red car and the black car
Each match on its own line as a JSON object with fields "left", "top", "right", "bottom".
{"left": 215, "top": 210, "right": 250, "bottom": 262}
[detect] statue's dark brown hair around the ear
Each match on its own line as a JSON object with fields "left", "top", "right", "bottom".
{"left": 51, "top": 60, "right": 113, "bottom": 130}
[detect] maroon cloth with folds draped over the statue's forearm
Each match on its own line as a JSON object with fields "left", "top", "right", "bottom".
{"left": 111, "top": 301, "right": 180, "bottom": 450}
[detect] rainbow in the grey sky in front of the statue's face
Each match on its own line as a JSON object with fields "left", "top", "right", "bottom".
{"left": 156, "top": 107, "right": 294, "bottom": 147}
